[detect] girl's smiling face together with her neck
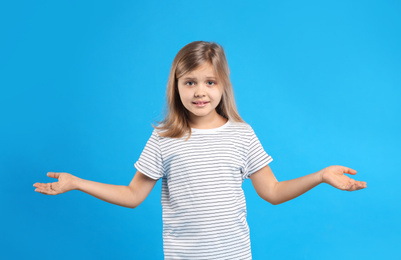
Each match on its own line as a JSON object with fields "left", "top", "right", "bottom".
{"left": 177, "top": 63, "right": 223, "bottom": 126}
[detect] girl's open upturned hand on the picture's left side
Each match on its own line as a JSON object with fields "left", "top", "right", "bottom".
{"left": 33, "top": 172, "right": 79, "bottom": 195}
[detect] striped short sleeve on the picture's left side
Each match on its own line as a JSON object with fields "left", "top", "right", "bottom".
{"left": 134, "top": 130, "right": 164, "bottom": 180}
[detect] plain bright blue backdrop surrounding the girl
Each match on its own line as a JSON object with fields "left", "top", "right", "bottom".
{"left": 0, "top": 0, "right": 401, "bottom": 260}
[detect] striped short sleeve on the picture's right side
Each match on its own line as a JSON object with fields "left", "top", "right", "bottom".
{"left": 243, "top": 127, "right": 273, "bottom": 179}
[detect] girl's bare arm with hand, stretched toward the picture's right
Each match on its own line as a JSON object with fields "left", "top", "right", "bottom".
{"left": 250, "top": 165, "right": 366, "bottom": 205}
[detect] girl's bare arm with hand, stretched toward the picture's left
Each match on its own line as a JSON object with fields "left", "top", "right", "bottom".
{"left": 33, "top": 171, "right": 156, "bottom": 208}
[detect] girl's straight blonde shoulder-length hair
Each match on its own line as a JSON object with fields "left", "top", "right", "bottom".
{"left": 154, "top": 41, "right": 244, "bottom": 138}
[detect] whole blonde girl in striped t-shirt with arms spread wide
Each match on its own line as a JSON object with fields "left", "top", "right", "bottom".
{"left": 34, "top": 41, "right": 366, "bottom": 259}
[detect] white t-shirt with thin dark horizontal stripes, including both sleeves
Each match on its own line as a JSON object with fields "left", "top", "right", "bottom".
{"left": 135, "top": 121, "right": 272, "bottom": 259}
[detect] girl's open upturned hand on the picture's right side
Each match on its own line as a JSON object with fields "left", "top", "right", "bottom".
{"left": 318, "top": 165, "right": 366, "bottom": 191}
